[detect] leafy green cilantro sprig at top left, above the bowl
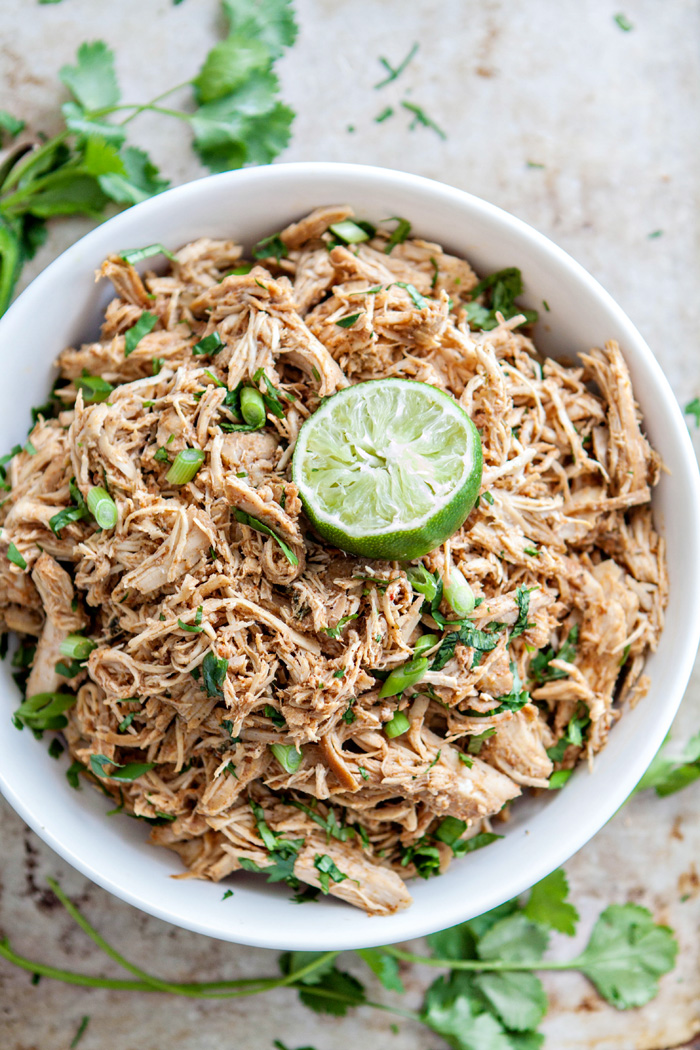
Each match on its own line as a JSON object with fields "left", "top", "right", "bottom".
{"left": 0, "top": 0, "right": 297, "bottom": 315}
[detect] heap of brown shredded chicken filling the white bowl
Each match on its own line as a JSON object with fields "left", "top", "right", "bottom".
{"left": 0, "top": 206, "right": 667, "bottom": 915}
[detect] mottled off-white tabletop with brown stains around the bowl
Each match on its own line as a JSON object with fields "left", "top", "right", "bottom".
{"left": 0, "top": 0, "right": 700, "bottom": 1050}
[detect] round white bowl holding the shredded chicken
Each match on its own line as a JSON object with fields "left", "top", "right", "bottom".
{"left": 0, "top": 164, "right": 700, "bottom": 950}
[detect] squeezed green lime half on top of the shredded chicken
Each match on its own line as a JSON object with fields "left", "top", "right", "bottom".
{"left": 292, "top": 379, "right": 482, "bottom": 561}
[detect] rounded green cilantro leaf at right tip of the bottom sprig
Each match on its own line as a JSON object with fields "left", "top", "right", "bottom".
{"left": 571, "top": 904, "right": 678, "bottom": 1010}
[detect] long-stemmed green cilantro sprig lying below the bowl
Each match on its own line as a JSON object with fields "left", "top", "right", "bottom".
{"left": 0, "top": 869, "right": 678, "bottom": 1050}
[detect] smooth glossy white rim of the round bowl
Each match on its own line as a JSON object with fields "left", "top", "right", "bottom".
{"left": 0, "top": 162, "right": 700, "bottom": 950}
